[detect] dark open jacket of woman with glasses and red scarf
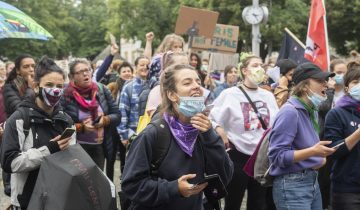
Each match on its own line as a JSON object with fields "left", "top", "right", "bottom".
{"left": 61, "top": 83, "right": 121, "bottom": 159}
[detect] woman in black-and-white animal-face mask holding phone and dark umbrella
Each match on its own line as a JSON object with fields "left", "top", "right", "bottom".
{"left": 0, "top": 57, "right": 75, "bottom": 209}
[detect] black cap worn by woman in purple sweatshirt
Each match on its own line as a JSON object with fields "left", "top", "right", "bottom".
{"left": 292, "top": 63, "right": 335, "bottom": 85}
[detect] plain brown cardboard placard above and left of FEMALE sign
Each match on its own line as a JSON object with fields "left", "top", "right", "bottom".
{"left": 175, "top": 6, "right": 219, "bottom": 38}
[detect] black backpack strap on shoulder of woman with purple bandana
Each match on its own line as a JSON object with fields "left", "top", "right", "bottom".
{"left": 150, "top": 118, "right": 171, "bottom": 176}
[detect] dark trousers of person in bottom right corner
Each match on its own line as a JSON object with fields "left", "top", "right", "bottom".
{"left": 332, "top": 192, "right": 360, "bottom": 210}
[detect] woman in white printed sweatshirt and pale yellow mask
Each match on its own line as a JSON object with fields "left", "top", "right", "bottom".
{"left": 210, "top": 55, "right": 278, "bottom": 210}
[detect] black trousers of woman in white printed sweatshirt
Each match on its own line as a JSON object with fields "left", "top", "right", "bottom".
{"left": 225, "top": 149, "right": 266, "bottom": 210}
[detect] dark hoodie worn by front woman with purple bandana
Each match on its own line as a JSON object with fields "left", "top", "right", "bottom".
{"left": 121, "top": 124, "right": 233, "bottom": 210}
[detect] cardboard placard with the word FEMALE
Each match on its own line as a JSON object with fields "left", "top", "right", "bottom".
{"left": 192, "top": 24, "right": 239, "bottom": 53}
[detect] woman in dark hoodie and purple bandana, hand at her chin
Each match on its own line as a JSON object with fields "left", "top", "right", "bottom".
{"left": 121, "top": 65, "right": 233, "bottom": 210}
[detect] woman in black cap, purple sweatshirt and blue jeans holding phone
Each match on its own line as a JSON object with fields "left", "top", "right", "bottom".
{"left": 269, "top": 63, "right": 335, "bottom": 210}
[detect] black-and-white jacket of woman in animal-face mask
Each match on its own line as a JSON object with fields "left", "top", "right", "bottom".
{"left": 0, "top": 99, "right": 75, "bottom": 209}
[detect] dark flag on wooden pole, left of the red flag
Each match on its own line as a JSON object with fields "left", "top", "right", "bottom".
{"left": 278, "top": 29, "right": 309, "bottom": 65}
